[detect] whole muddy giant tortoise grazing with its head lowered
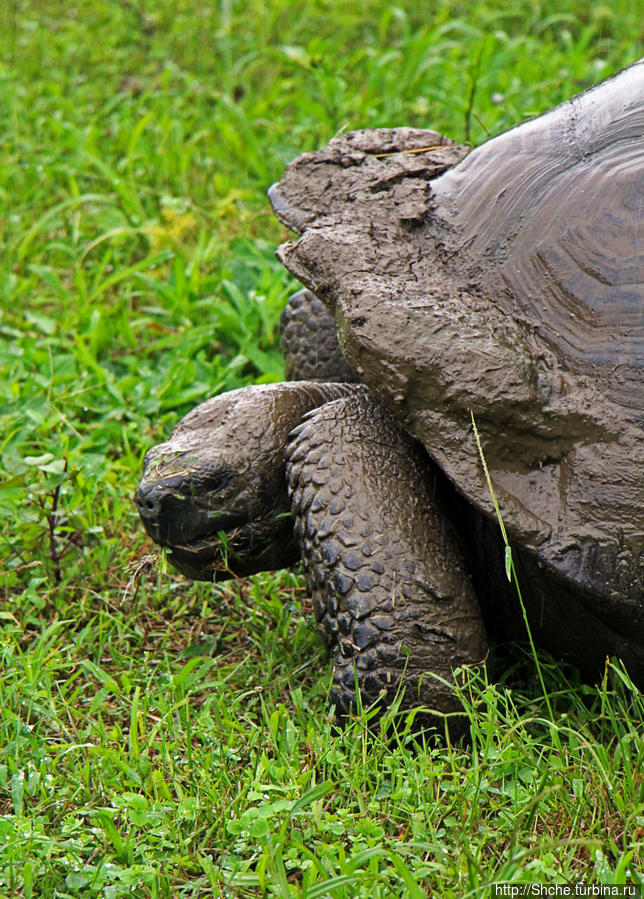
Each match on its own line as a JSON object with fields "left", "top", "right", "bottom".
{"left": 136, "top": 61, "right": 644, "bottom": 728}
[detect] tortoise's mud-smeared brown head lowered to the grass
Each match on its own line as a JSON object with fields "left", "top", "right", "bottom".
{"left": 134, "top": 382, "right": 354, "bottom": 581}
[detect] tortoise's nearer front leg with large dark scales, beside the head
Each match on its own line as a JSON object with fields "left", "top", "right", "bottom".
{"left": 287, "top": 388, "right": 487, "bottom": 736}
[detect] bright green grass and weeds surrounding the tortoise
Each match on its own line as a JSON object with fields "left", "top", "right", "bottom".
{"left": 0, "top": 0, "right": 644, "bottom": 899}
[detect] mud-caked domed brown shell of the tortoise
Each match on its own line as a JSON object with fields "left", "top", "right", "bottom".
{"left": 269, "top": 61, "right": 644, "bottom": 652}
